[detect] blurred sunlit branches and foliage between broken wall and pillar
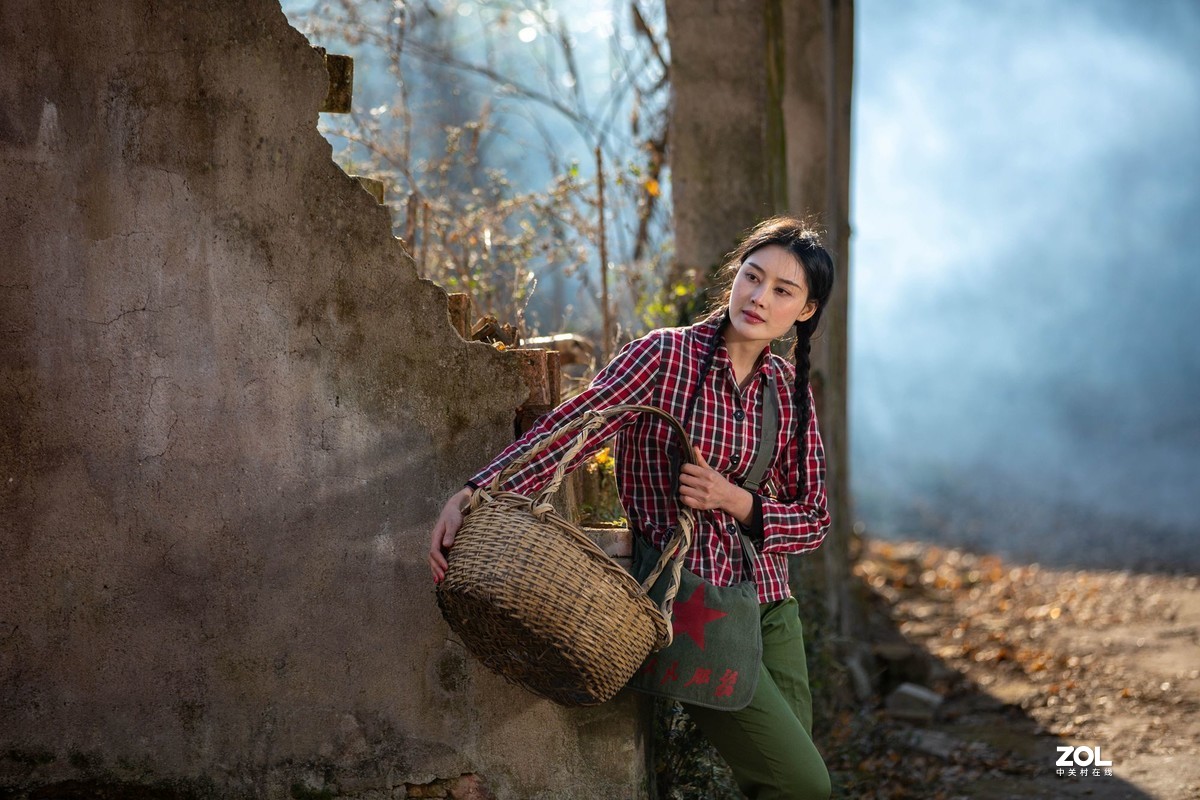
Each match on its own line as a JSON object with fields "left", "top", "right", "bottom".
{"left": 284, "top": 0, "right": 696, "bottom": 350}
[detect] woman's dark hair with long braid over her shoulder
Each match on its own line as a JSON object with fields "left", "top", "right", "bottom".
{"left": 719, "top": 217, "right": 836, "bottom": 449}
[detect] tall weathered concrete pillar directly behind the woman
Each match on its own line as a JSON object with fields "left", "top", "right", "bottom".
{"left": 667, "top": 0, "right": 853, "bottom": 628}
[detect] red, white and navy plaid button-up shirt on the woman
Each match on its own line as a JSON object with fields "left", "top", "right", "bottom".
{"left": 469, "top": 317, "right": 829, "bottom": 602}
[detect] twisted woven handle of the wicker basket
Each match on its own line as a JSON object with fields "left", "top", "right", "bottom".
{"left": 491, "top": 404, "right": 698, "bottom": 644}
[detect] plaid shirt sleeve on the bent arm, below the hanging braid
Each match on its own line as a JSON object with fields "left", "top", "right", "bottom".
{"left": 762, "top": 389, "right": 830, "bottom": 553}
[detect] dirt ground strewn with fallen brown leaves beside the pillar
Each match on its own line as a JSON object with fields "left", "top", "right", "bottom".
{"left": 840, "top": 541, "right": 1200, "bottom": 800}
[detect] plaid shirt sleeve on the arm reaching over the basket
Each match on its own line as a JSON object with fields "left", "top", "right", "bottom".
{"left": 467, "top": 333, "right": 661, "bottom": 495}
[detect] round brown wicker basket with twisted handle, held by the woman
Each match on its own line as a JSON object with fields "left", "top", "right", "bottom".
{"left": 437, "top": 405, "right": 694, "bottom": 706}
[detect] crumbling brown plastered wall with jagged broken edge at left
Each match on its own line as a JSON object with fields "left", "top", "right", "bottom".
{"left": 0, "top": 0, "right": 644, "bottom": 799}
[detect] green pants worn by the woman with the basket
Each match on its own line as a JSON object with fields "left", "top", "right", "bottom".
{"left": 684, "top": 597, "right": 830, "bottom": 800}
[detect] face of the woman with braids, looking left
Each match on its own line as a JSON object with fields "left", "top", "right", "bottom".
{"left": 727, "top": 245, "right": 817, "bottom": 342}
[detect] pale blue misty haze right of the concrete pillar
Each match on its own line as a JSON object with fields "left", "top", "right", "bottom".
{"left": 851, "top": 0, "right": 1200, "bottom": 570}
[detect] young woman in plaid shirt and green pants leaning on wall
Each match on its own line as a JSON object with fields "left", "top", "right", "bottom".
{"left": 430, "top": 217, "right": 834, "bottom": 800}
